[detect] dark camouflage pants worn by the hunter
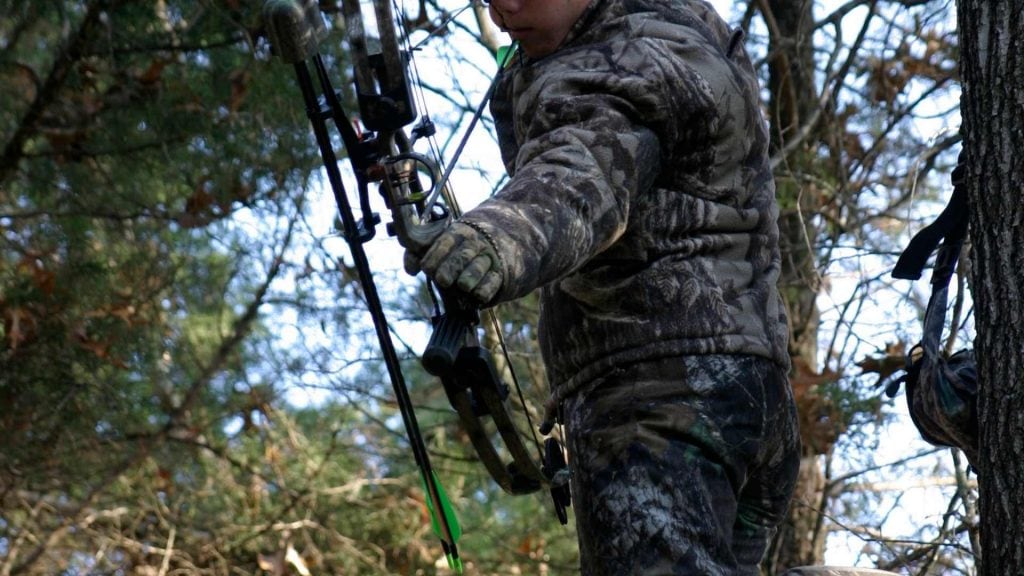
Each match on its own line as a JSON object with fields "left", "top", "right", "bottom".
{"left": 562, "top": 356, "right": 800, "bottom": 576}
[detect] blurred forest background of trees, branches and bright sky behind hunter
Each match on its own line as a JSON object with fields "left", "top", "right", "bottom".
{"left": 0, "top": 0, "right": 980, "bottom": 576}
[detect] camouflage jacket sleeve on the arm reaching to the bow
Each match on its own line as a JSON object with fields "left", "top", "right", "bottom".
{"left": 464, "top": 39, "right": 715, "bottom": 300}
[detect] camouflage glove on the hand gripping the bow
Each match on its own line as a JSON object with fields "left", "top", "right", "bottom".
{"left": 415, "top": 221, "right": 503, "bottom": 304}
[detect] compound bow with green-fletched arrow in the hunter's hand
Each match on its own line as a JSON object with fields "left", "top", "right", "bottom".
{"left": 264, "top": 0, "right": 569, "bottom": 568}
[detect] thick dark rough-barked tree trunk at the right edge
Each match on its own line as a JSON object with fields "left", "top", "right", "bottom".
{"left": 958, "top": 0, "right": 1024, "bottom": 576}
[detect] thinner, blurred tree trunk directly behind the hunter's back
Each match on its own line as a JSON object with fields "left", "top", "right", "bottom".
{"left": 758, "top": 0, "right": 830, "bottom": 574}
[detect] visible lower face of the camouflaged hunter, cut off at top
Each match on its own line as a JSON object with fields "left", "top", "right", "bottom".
{"left": 489, "top": 0, "right": 590, "bottom": 57}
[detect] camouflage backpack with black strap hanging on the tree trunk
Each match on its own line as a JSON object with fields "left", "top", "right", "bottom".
{"left": 886, "top": 152, "right": 979, "bottom": 464}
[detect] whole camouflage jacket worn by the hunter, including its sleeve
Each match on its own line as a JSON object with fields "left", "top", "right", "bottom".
{"left": 464, "top": 0, "right": 788, "bottom": 399}
